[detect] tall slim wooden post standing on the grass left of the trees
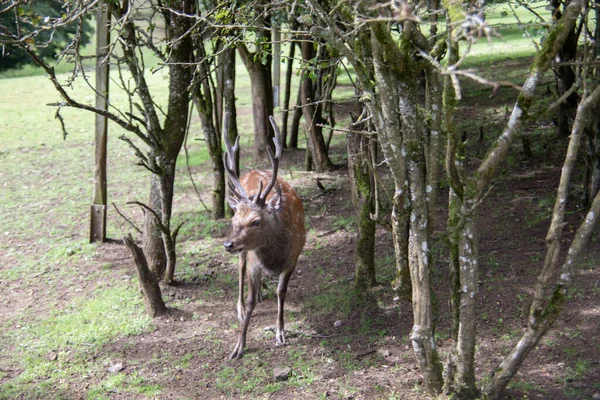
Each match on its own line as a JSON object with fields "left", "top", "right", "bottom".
{"left": 90, "top": 10, "right": 110, "bottom": 243}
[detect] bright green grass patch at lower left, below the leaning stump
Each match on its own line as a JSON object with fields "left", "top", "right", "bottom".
{"left": 0, "top": 285, "right": 153, "bottom": 399}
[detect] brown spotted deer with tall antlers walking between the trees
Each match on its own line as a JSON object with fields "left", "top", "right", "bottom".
{"left": 223, "top": 116, "right": 306, "bottom": 359}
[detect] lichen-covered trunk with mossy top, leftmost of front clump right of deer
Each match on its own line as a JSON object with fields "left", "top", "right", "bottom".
{"left": 371, "top": 21, "right": 442, "bottom": 394}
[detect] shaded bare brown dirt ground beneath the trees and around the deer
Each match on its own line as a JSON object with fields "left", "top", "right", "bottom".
{"left": 0, "top": 67, "right": 600, "bottom": 400}
